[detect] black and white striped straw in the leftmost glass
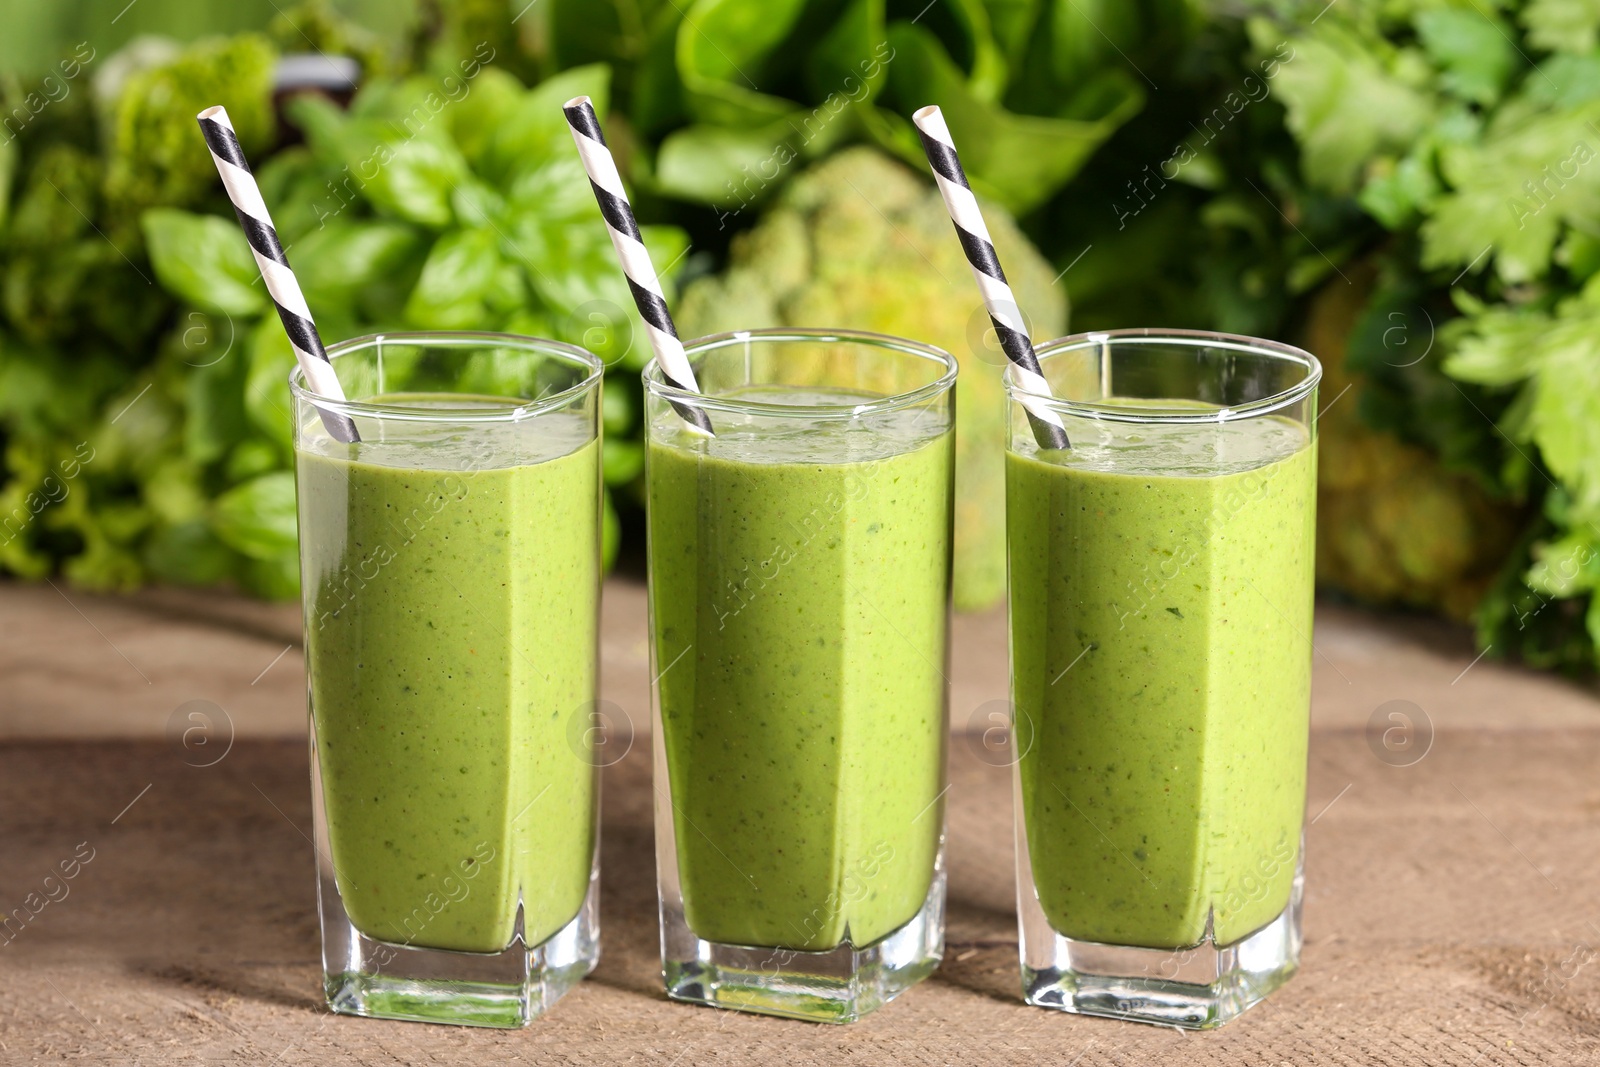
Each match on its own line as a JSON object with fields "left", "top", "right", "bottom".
{"left": 197, "top": 106, "right": 360, "bottom": 442}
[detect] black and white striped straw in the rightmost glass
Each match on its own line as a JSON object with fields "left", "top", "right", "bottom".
{"left": 912, "top": 106, "right": 1070, "bottom": 448}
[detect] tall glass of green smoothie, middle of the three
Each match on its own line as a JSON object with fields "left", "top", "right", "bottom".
{"left": 645, "top": 331, "right": 955, "bottom": 1022}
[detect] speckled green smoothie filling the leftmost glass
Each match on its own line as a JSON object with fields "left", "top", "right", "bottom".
{"left": 296, "top": 404, "right": 600, "bottom": 952}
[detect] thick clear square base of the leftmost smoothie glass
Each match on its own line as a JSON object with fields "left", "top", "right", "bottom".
{"left": 322, "top": 875, "right": 600, "bottom": 1027}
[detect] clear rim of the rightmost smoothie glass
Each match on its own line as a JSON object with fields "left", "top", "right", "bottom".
{"left": 1003, "top": 326, "right": 1322, "bottom": 424}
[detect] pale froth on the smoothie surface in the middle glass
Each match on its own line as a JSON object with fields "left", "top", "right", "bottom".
{"left": 651, "top": 386, "right": 949, "bottom": 464}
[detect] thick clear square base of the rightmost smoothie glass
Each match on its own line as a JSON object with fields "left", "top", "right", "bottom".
{"left": 1021, "top": 870, "right": 1304, "bottom": 1030}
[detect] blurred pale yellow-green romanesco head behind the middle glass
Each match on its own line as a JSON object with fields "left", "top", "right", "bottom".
{"left": 678, "top": 147, "right": 1067, "bottom": 609}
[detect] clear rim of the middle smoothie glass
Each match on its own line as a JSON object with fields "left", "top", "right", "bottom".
{"left": 640, "top": 326, "right": 960, "bottom": 419}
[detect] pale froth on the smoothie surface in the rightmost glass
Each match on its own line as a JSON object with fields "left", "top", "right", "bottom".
{"left": 1037, "top": 406, "right": 1309, "bottom": 478}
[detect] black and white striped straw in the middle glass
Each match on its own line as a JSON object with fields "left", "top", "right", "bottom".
{"left": 562, "top": 96, "right": 712, "bottom": 434}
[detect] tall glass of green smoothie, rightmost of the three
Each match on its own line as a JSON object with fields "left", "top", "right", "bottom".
{"left": 1006, "top": 330, "right": 1322, "bottom": 1029}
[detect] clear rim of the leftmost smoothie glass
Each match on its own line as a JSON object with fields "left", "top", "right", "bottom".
{"left": 290, "top": 330, "right": 605, "bottom": 422}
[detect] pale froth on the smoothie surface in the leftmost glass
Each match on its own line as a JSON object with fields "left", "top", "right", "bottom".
{"left": 301, "top": 394, "right": 594, "bottom": 470}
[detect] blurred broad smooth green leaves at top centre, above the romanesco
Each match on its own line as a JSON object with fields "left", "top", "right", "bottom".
{"left": 530, "top": 0, "right": 1164, "bottom": 211}
